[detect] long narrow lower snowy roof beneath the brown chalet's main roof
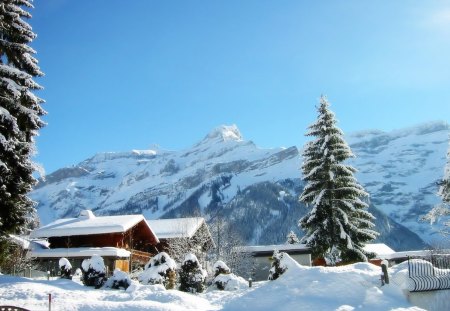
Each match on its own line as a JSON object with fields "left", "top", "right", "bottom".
{"left": 28, "top": 247, "right": 130, "bottom": 258}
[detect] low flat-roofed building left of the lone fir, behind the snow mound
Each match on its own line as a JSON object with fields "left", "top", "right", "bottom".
{"left": 236, "top": 244, "right": 311, "bottom": 281}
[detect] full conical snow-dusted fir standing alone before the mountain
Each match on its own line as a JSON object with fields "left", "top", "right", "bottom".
{"left": 299, "top": 96, "right": 378, "bottom": 264}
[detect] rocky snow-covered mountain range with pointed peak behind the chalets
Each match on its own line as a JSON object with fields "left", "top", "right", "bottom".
{"left": 31, "top": 122, "right": 450, "bottom": 250}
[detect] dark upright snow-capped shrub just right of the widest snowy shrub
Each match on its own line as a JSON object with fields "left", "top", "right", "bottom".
{"left": 180, "top": 253, "right": 207, "bottom": 293}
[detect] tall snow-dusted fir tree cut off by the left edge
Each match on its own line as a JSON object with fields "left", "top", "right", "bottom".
{"left": 0, "top": 0, "right": 45, "bottom": 265}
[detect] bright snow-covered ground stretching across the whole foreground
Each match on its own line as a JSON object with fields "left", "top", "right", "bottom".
{"left": 0, "top": 258, "right": 450, "bottom": 311}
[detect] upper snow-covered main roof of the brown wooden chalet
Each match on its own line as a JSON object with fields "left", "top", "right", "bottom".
{"left": 30, "top": 211, "right": 152, "bottom": 238}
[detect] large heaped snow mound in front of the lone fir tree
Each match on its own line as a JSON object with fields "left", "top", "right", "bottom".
{"left": 223, "top": 255, "right": 421, "bottom": 311}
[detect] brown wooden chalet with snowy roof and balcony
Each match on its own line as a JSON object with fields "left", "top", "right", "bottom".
{"left": 30, "top": 210, "right": 160, "bottom": 272}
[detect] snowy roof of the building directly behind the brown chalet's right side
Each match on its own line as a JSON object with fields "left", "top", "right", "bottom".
{"left": 147, "top": 217, "right": 205, "bottom": 239}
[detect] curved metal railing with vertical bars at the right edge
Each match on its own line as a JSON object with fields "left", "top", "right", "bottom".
{"left": 408, "top": 254, "right": 450, "bottom": 292}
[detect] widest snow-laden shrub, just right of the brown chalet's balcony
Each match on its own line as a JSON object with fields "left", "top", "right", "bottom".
{"left": 138, "top": 252, "right": 177, "bottom": 289}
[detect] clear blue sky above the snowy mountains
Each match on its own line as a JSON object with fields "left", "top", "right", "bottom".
{"left": 29, "top": 0, "right": 450, "bottom": 173}
